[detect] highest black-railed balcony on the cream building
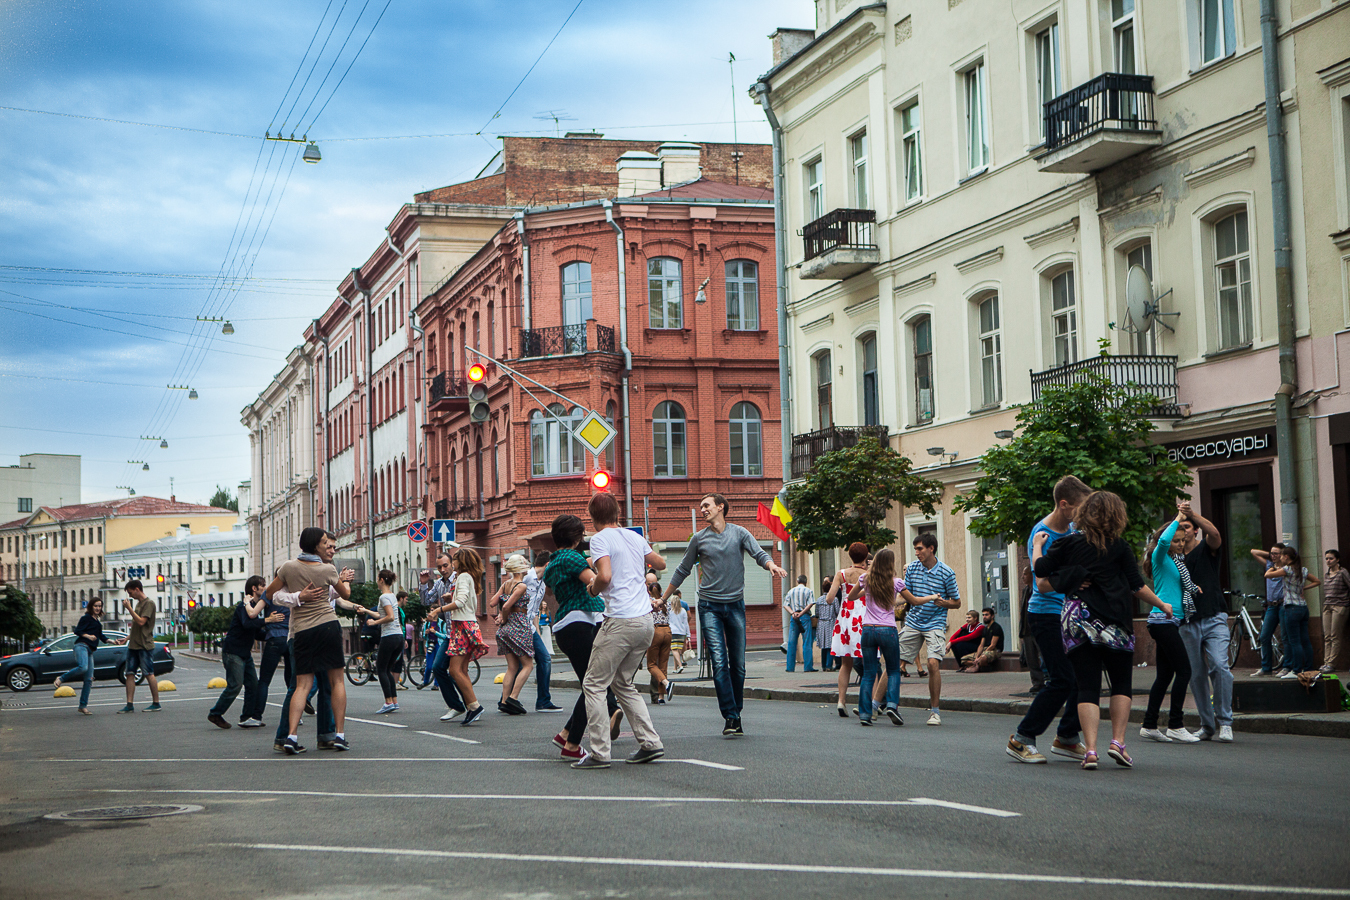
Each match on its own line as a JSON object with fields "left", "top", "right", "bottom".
{"left": 1037, "top": 72, "right": 1162, "bottom": 174}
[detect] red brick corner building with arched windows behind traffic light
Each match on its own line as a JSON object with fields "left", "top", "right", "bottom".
{"left": 416, "top": 142, "right": 783, "bottom": 644}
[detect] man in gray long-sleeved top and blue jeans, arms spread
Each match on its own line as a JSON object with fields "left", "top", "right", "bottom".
{"left": 663, "top": 494, "right": 787, "bottom": 737}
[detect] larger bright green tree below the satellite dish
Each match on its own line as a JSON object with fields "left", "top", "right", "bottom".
{"left": 954, "top": 376, "right": 1191, "bottom": 546}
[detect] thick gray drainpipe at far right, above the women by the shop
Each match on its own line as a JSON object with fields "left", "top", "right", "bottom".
{"left": 1261, "top": 0, "right": 1299, "bottom": 546}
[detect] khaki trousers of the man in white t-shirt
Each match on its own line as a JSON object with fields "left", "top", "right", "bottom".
{"left": 582, "top": 615, "right": 662, "bottom": 760}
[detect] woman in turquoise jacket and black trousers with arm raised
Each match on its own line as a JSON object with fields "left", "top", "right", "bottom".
{"left": 1139, "top": 510, "right": 1200, "bottom": 743}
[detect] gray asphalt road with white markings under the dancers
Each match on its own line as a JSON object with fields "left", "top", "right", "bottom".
{"left": 0, "top": 658, "right": 1350, "bottom": 900}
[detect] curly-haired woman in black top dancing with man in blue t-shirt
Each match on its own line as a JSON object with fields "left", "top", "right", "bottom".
{"left": 1031, "top": 491, "right": 1173, "bottom": 769}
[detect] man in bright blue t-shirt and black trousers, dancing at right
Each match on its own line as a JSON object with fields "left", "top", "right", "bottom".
{"left": 1007, "top": 475, "right": 1092, "bottom": 762}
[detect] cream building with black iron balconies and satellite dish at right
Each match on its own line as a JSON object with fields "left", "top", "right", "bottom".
{"left": 756, "top": 0, "right": 1350, "bottom": 647}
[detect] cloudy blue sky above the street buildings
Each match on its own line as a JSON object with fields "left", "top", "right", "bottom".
{"left": 0, "top": 0, "right": 814, "bottom": 502}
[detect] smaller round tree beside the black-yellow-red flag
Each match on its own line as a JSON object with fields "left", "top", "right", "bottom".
{"left": 787, "top": 439, "right": 942, "bottom": 553}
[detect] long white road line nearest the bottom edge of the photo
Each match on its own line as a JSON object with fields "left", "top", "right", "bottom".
{"left": 224, "top": 843, "right": 1350, "bottom": 897}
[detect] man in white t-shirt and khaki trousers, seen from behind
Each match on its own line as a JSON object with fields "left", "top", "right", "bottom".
{"left": 572, "top": 493, "right": 666, "bottom": 769}
